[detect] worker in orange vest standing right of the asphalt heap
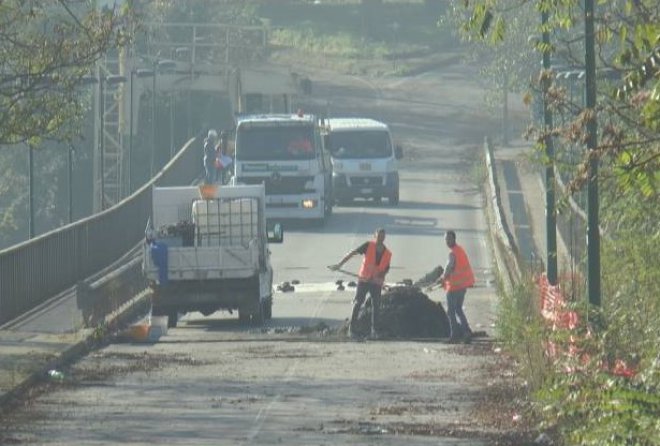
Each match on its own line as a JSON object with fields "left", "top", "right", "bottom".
{"left": 439, "top": 231, "right": 474, "bottom": 343}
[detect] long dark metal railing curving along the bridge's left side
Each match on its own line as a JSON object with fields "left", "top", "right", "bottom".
{"left": 0, "top": 134, "right": 202, "bottom": 325}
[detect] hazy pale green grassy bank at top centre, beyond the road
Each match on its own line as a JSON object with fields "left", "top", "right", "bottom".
{"left": 258, "top": 1, "right": 444, "bottom": 75}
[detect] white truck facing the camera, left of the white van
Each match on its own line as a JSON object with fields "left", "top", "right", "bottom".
{"left": 232, "top": 112, "right": 333, "bottom": 224}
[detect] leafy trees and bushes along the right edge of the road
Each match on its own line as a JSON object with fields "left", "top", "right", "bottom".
{"left": 443, "top": 0, "right": 660, "bottom": 446}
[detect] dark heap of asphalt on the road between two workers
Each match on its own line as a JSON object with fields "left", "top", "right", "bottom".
{"left": 351, "top": 285, "right": 449, "bottom": 339}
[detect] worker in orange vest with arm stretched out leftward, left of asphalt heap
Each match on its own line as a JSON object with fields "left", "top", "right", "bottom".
{"left": 329, "top": 228, "right": 392, "bottom": 339}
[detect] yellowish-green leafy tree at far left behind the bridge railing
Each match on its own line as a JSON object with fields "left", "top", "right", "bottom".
{"left": 0, "top": 0, "right": 132, "bottom": 246}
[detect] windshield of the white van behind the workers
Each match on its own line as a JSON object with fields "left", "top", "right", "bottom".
{"left": 330, "top": 130, "right": 392, "bottom": 159}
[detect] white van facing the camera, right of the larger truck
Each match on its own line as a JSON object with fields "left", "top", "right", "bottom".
{"left": 325, "top": 118, "right": 403, "bottom": 205}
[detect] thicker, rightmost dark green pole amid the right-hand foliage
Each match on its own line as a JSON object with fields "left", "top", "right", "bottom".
{"left": 584, "top": 0, "right": 600, "bottom": 306}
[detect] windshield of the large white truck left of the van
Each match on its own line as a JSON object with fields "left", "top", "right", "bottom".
{"left": 236, "top": 125, "right": 316, "bottom": 161}
